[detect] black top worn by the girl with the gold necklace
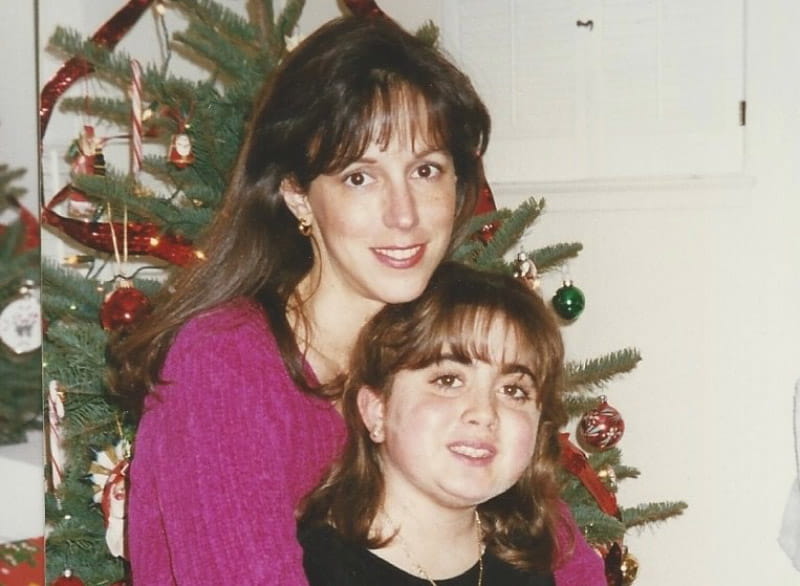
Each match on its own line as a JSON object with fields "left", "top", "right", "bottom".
{"left": 298, "top": 525, "right": 555, "bottom": 586}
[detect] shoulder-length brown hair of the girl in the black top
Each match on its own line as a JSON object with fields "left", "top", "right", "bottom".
{"left": 300, "top": 262, "right": 566, "bottom": 571}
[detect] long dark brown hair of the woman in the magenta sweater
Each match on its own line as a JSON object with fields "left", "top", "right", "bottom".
{"left": 109, "top": 17, "right": 490, "bottom": 413}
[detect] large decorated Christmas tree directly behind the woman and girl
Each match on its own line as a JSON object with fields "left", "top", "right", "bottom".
{"left": 41, "top": 0, "right": 685, "bottom": 584}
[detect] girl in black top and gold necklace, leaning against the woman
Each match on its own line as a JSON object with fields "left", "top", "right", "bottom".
{"left": 298, "top": 263, "right": 605, "bottom": 586}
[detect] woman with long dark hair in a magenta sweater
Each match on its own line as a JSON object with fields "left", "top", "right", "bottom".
{"left": 110, "top": 12, "right": 600, "bottom": 586}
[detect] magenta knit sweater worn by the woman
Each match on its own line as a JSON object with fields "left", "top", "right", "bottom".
{"left": 128, "top": 301, "right": 605, "bottom": 586}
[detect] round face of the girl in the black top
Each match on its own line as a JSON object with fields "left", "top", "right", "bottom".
{"left": 359, "top": 320, "right": 540, "bottom": 511}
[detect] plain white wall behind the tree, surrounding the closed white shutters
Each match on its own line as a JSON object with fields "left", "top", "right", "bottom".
{"left": 0, "top": 0, "right": 800, "bottom": 586}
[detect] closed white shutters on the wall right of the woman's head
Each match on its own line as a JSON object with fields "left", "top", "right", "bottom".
{"left": 441, "top": 0, "right": 744, "bottom": 182}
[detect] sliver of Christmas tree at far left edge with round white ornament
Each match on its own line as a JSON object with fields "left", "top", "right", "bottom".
{"left": 0, "top": 165, "right": 42, "bottom": 445}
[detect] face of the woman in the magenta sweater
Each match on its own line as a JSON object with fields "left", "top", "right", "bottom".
{"left": 284, "top": 119, "right": 456, "bottom": 311}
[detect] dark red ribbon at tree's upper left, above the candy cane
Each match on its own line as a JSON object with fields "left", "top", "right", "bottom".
{"left": 39, "top": 0, "right": 153, "bottom": 139}
